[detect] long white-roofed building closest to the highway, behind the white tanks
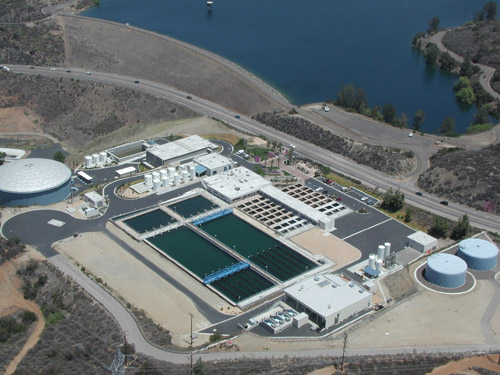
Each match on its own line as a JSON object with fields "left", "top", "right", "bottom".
{"left": 146, "top": 135, "right": 218, "bottom": 167}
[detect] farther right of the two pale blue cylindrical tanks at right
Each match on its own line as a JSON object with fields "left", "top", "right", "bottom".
{"left": 457, "top": 238, "right": 498, "bottom": 271}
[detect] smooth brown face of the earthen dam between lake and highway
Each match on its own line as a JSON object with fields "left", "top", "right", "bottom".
{"left": 60, "top": 16, "right": 278, "bottom": 115}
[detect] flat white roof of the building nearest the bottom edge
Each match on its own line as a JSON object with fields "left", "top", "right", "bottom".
{"left": 285, "top": 274, "right": 371, "bottom": 317}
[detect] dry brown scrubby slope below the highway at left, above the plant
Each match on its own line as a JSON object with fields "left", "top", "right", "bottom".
{"left": 0, "top": 71, "right": 196, "bottom": 151}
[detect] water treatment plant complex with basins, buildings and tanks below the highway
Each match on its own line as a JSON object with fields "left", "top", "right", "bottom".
{"left": 0, "top": 137, "right": 498, "bottom": 348}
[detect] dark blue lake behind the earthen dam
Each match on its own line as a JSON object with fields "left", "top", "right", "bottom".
{"left": 84, "top": 0, "right": 498, "bottom": 133}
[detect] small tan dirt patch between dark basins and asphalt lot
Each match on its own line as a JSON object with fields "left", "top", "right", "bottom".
{"left": 291, "top": 228, "right": 361, "bottom": 270}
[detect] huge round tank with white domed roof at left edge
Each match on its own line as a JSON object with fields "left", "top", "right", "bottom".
{"left": 0, "top": 159, "right": 71, "bottom": 206}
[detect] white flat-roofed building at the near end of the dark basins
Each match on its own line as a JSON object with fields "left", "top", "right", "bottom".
{"left": 284, "top": 274, "right": 372, "bottom": 329}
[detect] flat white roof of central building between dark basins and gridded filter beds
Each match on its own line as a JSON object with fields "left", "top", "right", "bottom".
{"left": 203, "top": 167, "right": 271, "bottom": 201}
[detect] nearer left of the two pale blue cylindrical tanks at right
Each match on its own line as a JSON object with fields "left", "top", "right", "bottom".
{"left": 424, "top": 253, "right": 467, "bottom": 288}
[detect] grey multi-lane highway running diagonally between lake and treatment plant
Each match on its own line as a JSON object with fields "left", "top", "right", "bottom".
{"left": 5, "top": 65, "right": 500, "bottom": 232}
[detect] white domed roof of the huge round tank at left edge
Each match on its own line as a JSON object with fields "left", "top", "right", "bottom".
{"left": 0, "top": 158, "right": 71, "bottom": 193}
